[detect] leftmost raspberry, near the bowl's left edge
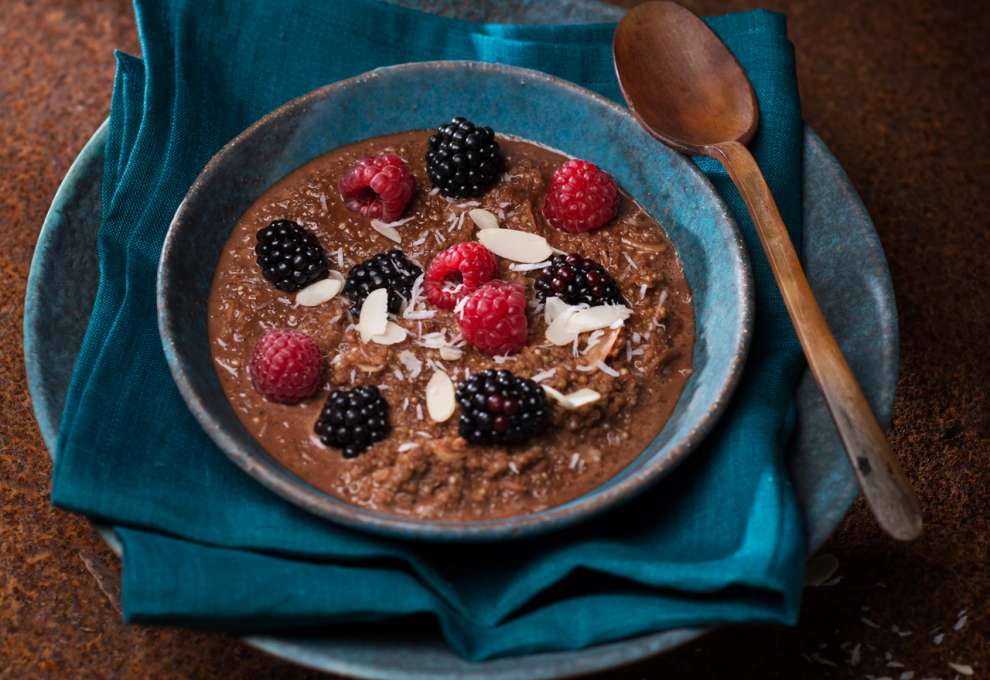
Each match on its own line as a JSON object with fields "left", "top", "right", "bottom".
{"left": 249, "top": 330, "right": 323, "bottom": 404}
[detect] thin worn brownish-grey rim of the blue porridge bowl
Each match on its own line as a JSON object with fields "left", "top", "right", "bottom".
{"left": 156, "top": 60, "right": 754, "bottom": 542}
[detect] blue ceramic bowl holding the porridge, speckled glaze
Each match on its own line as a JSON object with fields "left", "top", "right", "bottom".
{"left": 158, "top": 62, "right": 753, "bottom": 541}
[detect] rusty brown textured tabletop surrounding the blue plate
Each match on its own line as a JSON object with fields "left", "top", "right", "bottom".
{"left": 0, "top": 0, "right": 990, "bottom": 680}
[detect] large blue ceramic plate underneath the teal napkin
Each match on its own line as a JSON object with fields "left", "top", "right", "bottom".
{"left": 24, "top": 125, "right": 897, "bottom": 680}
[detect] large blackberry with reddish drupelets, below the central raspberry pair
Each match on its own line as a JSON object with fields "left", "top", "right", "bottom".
{"left": 456, "top": 368, "right": 550, "bottom": 444}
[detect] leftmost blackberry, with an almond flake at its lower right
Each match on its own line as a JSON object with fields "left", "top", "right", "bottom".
{"left": 254, "top": 220, "right": 327, "bottom": 293}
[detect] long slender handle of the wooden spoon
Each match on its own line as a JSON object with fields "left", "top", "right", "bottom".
{"left": 706, "top": 142, "right": 922, "bottom": 541}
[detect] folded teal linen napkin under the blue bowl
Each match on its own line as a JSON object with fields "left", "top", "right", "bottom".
{"left": 52, "top": 0, "right": 805, "bottom": 659}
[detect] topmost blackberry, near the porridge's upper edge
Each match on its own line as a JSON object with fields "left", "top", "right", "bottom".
{"left": 426, "top": 116, "right": 505, "bottom": 198}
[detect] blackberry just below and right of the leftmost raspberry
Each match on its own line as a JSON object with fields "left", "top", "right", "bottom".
{"left": 313, "top": 385, "right": 391, "bottom": 458}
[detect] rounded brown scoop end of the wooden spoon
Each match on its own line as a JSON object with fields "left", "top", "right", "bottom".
{"left": 613, "top": 2, "right": 759, "bottom": 154}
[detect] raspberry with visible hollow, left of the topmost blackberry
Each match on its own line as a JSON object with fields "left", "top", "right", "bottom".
{"left": 338, "top": 153, "right": 416, "bottom": 222}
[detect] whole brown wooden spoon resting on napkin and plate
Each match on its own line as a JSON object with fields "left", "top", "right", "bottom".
{"left": 613, "top": 2, "right": 921, "bottom": 540}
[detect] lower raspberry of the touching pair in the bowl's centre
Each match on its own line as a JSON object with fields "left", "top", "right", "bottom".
{"left": 457, "top": 280, "right": 529, "bottom": 356}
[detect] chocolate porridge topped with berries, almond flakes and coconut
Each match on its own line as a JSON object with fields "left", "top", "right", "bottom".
{"left": 209, "top": 118, "right": 694, "bottom": 520}
